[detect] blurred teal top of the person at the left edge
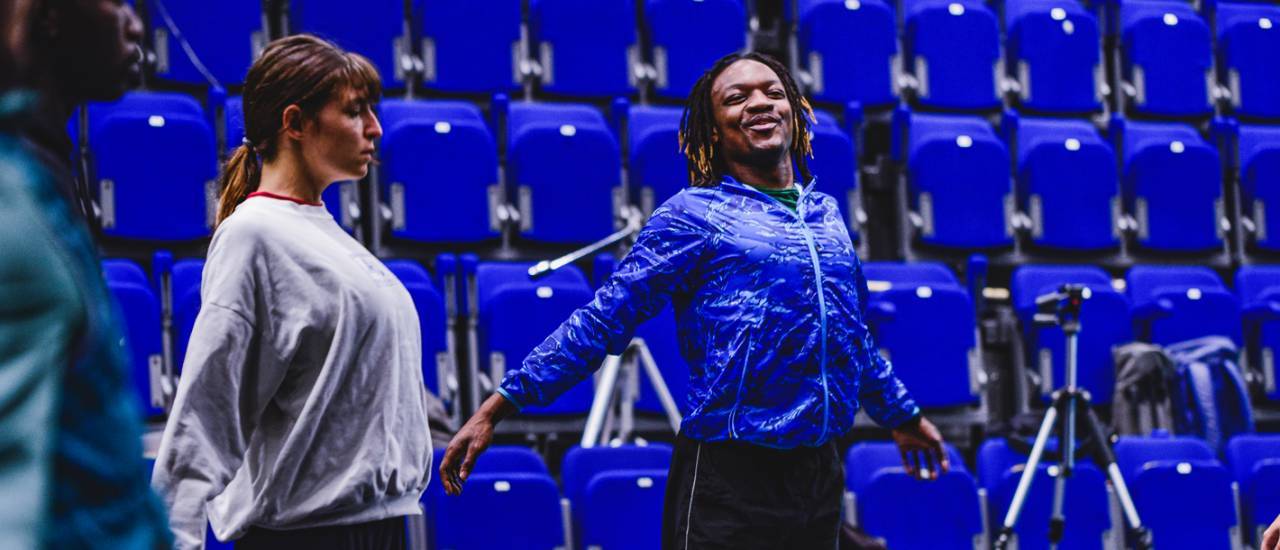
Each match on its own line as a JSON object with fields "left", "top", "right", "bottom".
{"left": 0, "top": 92, "right": 173, "bottom": 550}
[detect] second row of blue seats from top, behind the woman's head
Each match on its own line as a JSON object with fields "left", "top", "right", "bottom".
{"left": 77, "top": 92, "right": 1280, "bottom": 253}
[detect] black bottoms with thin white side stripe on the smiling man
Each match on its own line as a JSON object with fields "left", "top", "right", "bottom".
{"left": 662, "top": 435, "right": 845, "bottom": 550}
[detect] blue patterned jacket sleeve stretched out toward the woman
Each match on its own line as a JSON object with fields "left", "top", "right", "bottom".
{"left": 498, "top": 202, "right": 707, "bottom": 409}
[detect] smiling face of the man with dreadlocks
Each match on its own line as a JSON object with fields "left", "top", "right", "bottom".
{"left": 712, "top": 59, "right": 794, "bottom": 165}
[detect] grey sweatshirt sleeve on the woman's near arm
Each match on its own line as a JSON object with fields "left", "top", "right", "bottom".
{"left": 152, "top": 226, "right": 284, "bottom": 549}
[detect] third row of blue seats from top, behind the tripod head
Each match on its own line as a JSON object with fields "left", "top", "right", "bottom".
{"left": 104, "top": 246, "right": 1280, "bottom": 427}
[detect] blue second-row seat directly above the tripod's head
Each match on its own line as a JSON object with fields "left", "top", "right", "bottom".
{"left": 1016, "top": 119, "right": 1121, "bottom": 251}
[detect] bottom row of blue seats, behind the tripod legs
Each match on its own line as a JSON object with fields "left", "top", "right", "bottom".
{"left": 368, "top": 435, "right": 1280, "bottom": 550}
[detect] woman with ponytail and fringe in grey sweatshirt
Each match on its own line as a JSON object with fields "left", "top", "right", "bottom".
{"left": 152, "top": 35, "right": 431, "bottom": 550}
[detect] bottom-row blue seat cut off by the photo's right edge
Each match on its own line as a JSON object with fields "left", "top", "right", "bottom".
{"left": 1226, "top": 434, "right": 1280, "bottom": 547}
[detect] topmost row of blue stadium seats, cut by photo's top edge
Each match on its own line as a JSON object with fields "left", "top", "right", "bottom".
{"left": 151, "top": 0, "right": 1280, "bottom": 118}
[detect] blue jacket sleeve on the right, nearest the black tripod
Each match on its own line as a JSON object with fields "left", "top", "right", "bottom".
{"left": 854, "top": 257, "right": 920, "bottom": 428}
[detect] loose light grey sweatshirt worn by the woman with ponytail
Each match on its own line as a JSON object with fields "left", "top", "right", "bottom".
{"left": 152, "top": 196, "right": 431, "bottom": 549}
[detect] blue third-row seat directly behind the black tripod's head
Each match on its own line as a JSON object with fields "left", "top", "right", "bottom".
{"left": 1010, "top": 266, "right": 1133, "bottom": 404}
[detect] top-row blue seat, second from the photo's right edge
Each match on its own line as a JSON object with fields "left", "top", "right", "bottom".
{"left": 1120, "top": 0, "right": 1213, "bottom": 116}
